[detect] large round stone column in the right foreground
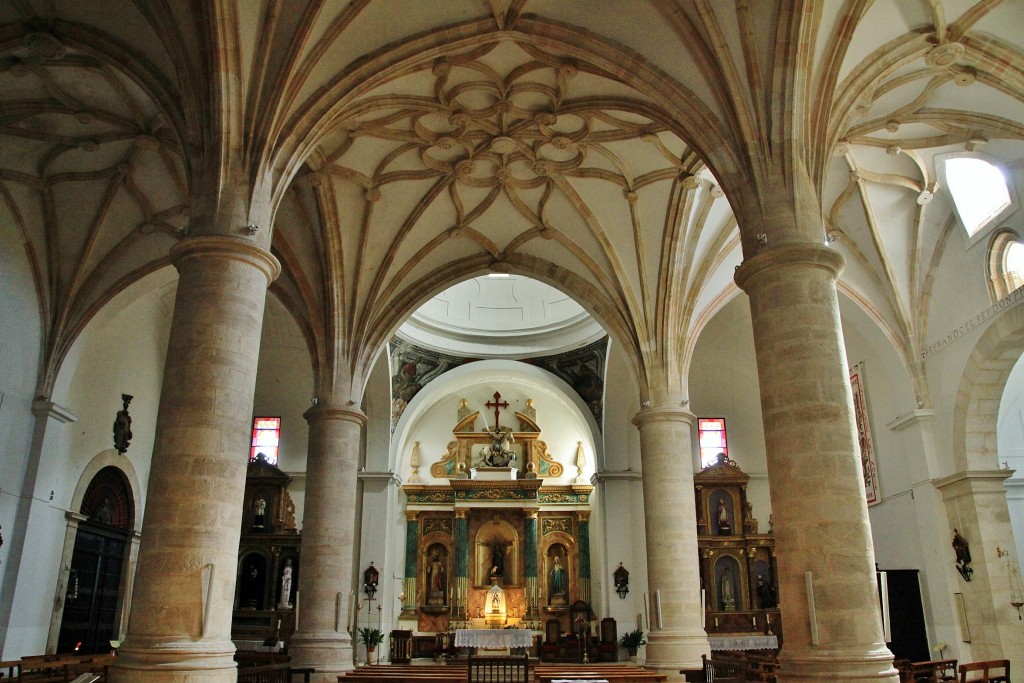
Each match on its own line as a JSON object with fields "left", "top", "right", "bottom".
{"left": 735, "top": 244, "right": 898, "bottom": 683}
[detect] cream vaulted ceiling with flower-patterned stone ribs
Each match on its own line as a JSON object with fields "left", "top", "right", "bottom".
{"left": 0, "top": 0, "right": 1024, "bottom": 398}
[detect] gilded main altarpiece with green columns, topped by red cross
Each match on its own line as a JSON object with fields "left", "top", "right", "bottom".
{"left": 399, "top": 392, "right": 594, "bottom": 633}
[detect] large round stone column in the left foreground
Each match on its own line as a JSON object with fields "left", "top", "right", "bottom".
{"left": 112, "top": 236, "right": 280, "bottom": 683}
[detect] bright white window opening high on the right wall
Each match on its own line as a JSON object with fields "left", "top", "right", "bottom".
{"left": 942, "top": 154, "right": 1011, "bottom": 238}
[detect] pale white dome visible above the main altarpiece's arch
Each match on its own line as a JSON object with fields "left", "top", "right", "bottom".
{"left": 398, "top": 273, "right": 605, "bottom": 358}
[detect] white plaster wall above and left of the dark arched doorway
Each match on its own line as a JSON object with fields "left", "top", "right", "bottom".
{"left": 3, "top": 268, "right": 176, "bottom": 658}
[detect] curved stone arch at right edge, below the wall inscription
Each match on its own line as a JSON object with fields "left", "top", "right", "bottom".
{"left": 953, "top": 305, "right": 1024, "bottom": 472}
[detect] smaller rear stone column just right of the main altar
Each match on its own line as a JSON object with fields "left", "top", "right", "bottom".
{"left": 633, "top": 407, "right": 711, "bottom": 680}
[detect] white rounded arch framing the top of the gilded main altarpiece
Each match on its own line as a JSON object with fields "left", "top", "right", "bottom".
{"left": 388, "top": 359, "right": 604, "bottom": 476}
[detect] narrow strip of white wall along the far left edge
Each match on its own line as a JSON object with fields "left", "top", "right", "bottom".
{"left": 0, "top": 196, "right": 42, "bottom": 658}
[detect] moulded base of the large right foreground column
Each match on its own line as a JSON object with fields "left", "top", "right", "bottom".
{"left": 775, "top": 646, "right": 899, "bottom": 683}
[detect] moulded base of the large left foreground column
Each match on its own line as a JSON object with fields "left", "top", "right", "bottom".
{"left": 110, "top": 639, "right": 238, "bottom": 683}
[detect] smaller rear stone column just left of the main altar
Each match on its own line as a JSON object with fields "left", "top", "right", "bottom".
{"left": 290, "top": 400, "right": 367, "bottom": 681}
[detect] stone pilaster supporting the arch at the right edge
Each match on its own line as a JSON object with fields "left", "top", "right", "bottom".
{"left": 935, "top": 470, "right": 1024, "bottom": 671}
